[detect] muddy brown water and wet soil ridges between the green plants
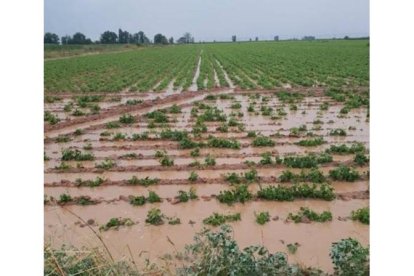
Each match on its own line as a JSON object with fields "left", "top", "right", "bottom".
{"left": 44, "top": 91, "right": 370, "bottom": 273}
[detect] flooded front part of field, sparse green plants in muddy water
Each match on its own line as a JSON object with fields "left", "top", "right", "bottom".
{"left": 44, "top": 88, "right": 369, "bottom": 273}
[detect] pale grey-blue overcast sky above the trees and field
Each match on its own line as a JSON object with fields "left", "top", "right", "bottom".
{"left": 44, "top": 0, "right": 369, "bottom": 42}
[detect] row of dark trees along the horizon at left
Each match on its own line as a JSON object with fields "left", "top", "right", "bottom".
{"left": 43, "top": 29, "right": 194, "bottom": 45}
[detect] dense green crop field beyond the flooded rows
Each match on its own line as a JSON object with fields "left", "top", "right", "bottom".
{"left": 44, "top": 40, "right": 369, "bottom": 93}
